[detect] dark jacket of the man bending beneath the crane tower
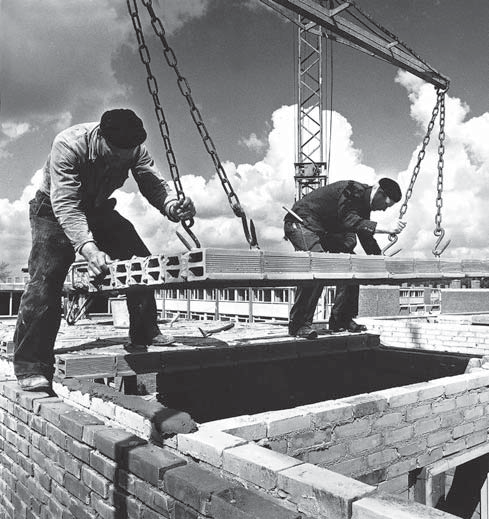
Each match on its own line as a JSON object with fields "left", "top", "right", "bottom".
{"left": 285, "top": 180, "right": 381, "bottom": 255}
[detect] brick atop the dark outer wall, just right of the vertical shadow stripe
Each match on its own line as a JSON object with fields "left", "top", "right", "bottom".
{"left": 122, "top": 445, "right": 187, "bottom": 487}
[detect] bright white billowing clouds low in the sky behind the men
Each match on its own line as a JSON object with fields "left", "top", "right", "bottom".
{"left": 0, "top": 73, "right": 489, "bottom": 276}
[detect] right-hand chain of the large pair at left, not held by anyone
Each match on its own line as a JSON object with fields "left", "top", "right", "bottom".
{"left": 139, "top": 0, "right": 259, "bottom": 248}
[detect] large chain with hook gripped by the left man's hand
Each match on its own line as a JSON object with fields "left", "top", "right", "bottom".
{"left": 127, "top": 0, "right": 200, "bottom": 248}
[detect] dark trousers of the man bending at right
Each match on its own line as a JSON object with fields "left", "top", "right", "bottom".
{"left": 284, "top": 221, "right": 359, "bottom": 333}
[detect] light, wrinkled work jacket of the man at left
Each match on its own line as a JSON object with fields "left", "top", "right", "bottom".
{"left": 40, "top": 123, "right": 177, "bottom": 252}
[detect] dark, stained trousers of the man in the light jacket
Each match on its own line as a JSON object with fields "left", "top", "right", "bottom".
{"left": 14, "top": 191, "right": 159, "bottom": 379}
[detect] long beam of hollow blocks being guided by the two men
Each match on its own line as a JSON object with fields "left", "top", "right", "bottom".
{"left": 66, "top": 248, "right": 489, "bottom": 291}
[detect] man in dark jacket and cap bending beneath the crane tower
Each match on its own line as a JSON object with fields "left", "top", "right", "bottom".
{"left": 284, "top": 178, "right": 406, "bottom": 339}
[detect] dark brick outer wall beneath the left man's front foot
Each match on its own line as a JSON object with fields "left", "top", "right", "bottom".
{"left": 0, "top": 380, "right": 300, "bottom": 519}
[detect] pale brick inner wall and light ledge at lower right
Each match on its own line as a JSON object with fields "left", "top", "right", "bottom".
{"left": 173, "top": 370, "right": 489, "bottom": 519}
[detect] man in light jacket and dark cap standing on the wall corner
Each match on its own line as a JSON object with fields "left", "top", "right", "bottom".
{"left": 14, "top": 109, "right": 195, "bottom": 391}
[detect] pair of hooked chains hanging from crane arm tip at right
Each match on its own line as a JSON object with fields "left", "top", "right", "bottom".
{"left": 382, "top": 88, "right": 450, "bottom": 256}
